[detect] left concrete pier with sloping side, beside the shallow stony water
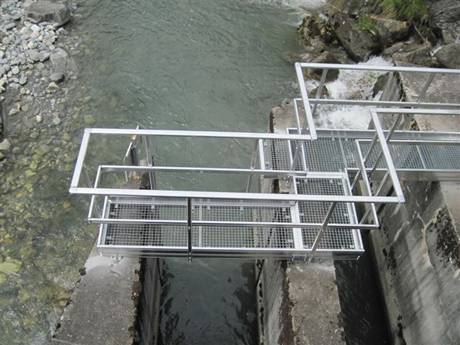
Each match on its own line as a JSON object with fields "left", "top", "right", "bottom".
{"left": 52, "top": 250, "right": 140, "bottom": 345}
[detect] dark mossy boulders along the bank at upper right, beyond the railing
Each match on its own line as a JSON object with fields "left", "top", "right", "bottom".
{"left": 296, "top": 0, "right": 460, "bottom": 70}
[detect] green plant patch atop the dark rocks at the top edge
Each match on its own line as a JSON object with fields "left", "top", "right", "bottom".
{"left": 380, "top": 0, "right": 428, "bottom": 22}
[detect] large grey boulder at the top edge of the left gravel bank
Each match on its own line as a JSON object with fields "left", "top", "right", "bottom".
{"left": 24, "top": 0, "right": 71, "bottom": 26}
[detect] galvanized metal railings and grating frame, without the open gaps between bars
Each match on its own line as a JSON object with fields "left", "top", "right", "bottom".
{"left": 70, "top": 63, "right": 460, "bottom": 260}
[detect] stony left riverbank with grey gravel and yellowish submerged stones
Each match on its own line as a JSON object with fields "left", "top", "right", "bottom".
{"left": 0, "top": 0, "right": 95, "bottom": 344}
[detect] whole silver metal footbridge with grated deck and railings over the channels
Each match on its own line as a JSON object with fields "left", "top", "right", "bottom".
{"left": 70, "top": 63, "right": 460, "bottom": 259}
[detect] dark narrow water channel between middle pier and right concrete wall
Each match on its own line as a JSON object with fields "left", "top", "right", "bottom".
{"left": 334, "top": 232, "right": 391, "bottom": 345}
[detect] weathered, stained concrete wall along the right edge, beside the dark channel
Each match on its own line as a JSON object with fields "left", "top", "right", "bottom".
{"left": 370, "top": 71, "right": 460, "bottom": 345}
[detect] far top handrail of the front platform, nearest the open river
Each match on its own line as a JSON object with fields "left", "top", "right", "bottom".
{"left": 86, "top": 128, "right": 311, "bottom": 141}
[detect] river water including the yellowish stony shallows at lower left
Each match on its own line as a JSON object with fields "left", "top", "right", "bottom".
{"left": 0, "top": 0, "right": 394, "bottom": 345}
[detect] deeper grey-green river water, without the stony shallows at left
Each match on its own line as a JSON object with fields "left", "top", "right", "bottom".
{"left": 74, "top": 0, "right": 306, "bottom": 345}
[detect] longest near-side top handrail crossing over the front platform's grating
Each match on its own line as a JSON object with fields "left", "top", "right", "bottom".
{"left": 69, "top": 188, "right": 400, "bottom": 203}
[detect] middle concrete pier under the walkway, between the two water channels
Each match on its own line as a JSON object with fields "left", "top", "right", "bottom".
{"left": 258, "top": 103, "right": 345, "bottom": 345}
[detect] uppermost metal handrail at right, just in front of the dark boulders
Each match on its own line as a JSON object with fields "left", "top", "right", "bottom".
{"left": 297, "top": 62, "right": 460, "bottom": 74}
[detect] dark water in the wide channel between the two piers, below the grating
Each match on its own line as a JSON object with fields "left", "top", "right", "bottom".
{"left": 159, "top": 259, "right": 258, "bottom": 345}
